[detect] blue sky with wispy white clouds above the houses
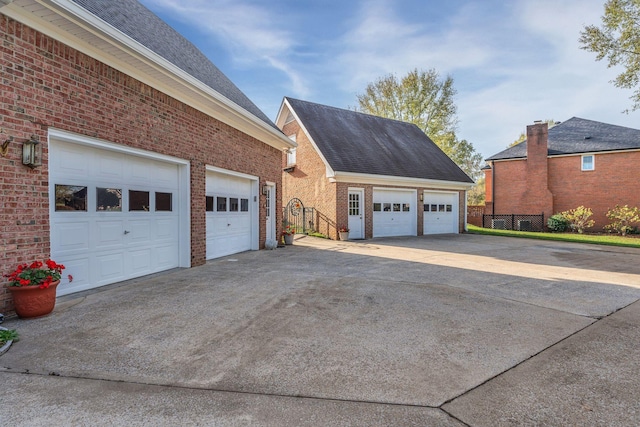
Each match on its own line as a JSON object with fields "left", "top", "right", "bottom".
{"left": 142, "top": 0, "right": 640, "bottom": 157}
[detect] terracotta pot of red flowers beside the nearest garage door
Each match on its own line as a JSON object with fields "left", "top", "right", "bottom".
{"left": 5, "top": 259, "right": 71, "bottom": 318}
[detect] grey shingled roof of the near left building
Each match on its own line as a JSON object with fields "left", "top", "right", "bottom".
{"left": 73, "top": 0, "right": 276, "bottom": 127}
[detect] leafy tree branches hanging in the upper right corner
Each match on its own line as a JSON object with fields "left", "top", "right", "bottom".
{"left": 580, "top": 0, "right": 640, "bottom": 110}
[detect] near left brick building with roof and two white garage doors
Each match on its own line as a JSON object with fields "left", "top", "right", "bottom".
{"left": 0, "top": 0, "right": 295, "bottom": 312}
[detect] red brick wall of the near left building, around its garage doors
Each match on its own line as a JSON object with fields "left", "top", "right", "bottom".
{"left": 0, "top": 14, "right": 282, "bottom": 312}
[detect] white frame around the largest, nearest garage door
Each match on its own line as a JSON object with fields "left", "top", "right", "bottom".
{"left": 47, "top": 128, "right": 191, "bottom": 274}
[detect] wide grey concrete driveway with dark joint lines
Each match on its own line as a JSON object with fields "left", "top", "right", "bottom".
{"left": 0, "top": 235, "right": 640, "bottom": 426}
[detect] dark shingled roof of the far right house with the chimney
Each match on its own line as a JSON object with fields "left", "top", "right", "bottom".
{"left": 486, "top": 117, "right": 640, "bottom": 160}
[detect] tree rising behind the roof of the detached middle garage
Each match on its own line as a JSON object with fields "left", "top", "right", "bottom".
{"left": 356, "top": 69, "right": 482, "bottom": 179}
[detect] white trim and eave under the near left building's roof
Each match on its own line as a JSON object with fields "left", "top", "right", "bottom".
{"left": 2, "top": 0, "right": 294, "bottom": 150}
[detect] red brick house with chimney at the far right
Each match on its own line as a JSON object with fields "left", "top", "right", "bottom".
{"left": 484, "top": 117, "right": 640, "bottom": 230}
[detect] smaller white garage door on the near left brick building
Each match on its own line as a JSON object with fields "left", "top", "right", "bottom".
{"left": 207, "top": 171, "right": 257, "bottom": 259}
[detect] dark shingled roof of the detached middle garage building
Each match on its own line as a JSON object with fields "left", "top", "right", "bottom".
{"left": 285, "top": 98, "right": 473, "bottom": 183}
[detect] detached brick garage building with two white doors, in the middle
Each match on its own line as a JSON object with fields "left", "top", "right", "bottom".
{"left": 276, "top": 98, "right": 473, "bottom": 239}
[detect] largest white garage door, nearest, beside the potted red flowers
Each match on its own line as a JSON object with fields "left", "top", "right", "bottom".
{"left": 49, "top": 140, "right": 188, "bottom": 295}
